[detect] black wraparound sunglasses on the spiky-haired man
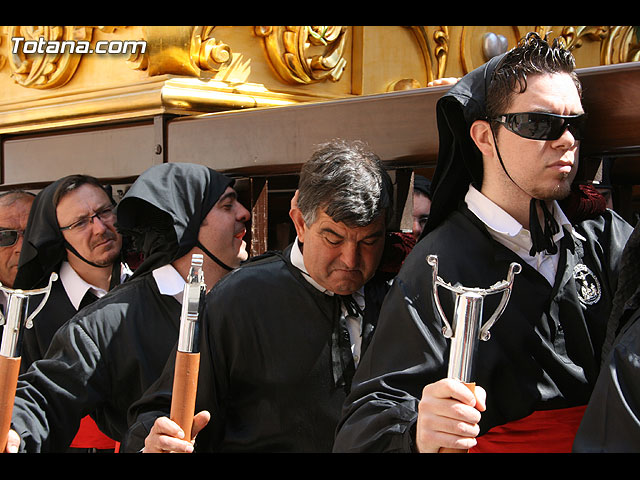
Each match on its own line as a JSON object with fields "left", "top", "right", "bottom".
{"left": 493, "top": 112, "right": 587, "bottom": 140}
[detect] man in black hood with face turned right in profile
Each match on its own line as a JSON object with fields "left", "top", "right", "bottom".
{"left": 3, "top": 163, "right": 249, "bottom": 452}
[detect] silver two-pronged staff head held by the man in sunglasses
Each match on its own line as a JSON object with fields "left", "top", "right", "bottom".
{"left": 427, "top": 255, "right": 522, "bottom": 453}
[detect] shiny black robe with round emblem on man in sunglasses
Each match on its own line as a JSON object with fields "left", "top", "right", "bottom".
{"left": 335, "top": 206, "right": 631, "bottom": 452}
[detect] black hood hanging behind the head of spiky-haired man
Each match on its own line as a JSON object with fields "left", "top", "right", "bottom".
{"left": 422, "top": 54, "right": 505, "bottom": 237}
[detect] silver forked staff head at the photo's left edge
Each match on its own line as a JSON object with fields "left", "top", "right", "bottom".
{"left": 0, "top": 272, "right": 58, "bottom": 358}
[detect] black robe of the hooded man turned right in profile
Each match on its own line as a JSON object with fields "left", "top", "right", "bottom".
{"left": 12, "top": 275, "right": 180, "bottom": 453}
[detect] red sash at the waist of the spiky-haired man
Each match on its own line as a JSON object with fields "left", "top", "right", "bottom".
{"left": 469, "top": 405, "right": 586, "bottom": 453}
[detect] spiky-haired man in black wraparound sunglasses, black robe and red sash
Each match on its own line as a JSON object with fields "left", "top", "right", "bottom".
{"left": 335, "top": 34, "right": 631, "bottom": 452}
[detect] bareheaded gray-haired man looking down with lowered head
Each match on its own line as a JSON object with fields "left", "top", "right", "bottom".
{"left": 126, "top": 141, "right": 393, "bottom": 452}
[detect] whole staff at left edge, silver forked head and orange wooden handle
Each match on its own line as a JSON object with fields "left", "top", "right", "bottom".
{"left": 0, "top": 272, "right": 58, "bottom": 452}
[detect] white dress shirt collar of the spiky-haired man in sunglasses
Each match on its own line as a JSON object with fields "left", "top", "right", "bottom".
{"left": 464, "top": 185, "right": 585, "bottom": 285}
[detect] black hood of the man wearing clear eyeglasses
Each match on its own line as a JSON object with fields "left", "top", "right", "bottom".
{"left": 14, "top": 177, "right": 120, "bottom": 290}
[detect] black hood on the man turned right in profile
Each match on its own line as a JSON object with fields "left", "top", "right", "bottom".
{"left": 116, "top": 163, "right": 234, "bottom": 277}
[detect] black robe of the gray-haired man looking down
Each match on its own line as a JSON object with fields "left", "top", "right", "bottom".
{"left": 126, "top": 247, "right": 388, "bottom": 452}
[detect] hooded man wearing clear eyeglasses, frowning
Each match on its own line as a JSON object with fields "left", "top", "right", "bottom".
{"left": 10, "top": 175, "right": 131, "bottom": 452}
